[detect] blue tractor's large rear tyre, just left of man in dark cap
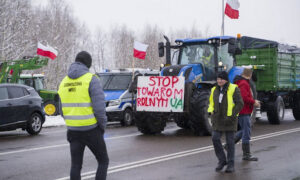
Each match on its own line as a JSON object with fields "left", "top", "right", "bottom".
{"left": 189, "top": 89, "right": 212, "bottom": 135}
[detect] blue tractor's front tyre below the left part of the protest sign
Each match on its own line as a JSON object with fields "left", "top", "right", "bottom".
{"left": 135, "top": 112, "right": 166, "bottom": 134}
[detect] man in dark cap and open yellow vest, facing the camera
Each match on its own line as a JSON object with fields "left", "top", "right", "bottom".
{"left": 208, "top": 71, "right": 244, "bottom": 173}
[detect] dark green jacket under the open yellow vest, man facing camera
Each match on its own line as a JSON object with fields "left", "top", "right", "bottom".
{"left": 211, "top": 83, "right": 244, "bottom": 131}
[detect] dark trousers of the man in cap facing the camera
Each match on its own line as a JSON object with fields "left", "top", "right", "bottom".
{"left": 212, "top": 131, "right": 235, "bottom": 166}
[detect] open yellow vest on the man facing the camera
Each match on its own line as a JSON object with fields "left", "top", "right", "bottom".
{"left": 208, "top": 83, "right": 238, "bottom": 116}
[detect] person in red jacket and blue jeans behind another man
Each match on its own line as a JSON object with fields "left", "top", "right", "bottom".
{"left": 234, "top": 68, "right": 260, "bottom": 161}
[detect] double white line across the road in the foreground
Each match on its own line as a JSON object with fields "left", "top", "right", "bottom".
{"left": 56, "top": 128, "right": 300, "bottom": 180}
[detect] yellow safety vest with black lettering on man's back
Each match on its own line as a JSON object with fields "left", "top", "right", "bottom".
{"left": 58, "top": 73, "right": 97, "bottom": 129}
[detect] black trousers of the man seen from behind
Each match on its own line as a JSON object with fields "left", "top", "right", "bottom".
{"left": 67, "top": 127, "right": 109, "bottom": 180}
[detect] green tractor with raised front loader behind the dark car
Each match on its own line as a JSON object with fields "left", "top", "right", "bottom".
{"left": 0, "top": 57, "right": 59, "bottom": 116}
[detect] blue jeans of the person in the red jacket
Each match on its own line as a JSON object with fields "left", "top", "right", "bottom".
{"left": 235, "top": 115, "right": 251, "bottom": 144}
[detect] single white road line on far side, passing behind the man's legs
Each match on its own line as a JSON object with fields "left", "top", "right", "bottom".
{"left": 0, "top": 127, "right": 180, "bottom": 156}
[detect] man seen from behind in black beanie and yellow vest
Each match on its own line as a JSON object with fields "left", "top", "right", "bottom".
{"left": 58, "top": 51, "right": 109, "bottom": 180}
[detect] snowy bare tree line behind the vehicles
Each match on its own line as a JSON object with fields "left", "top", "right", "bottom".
{"left": 0, "top": 0, "right": 209, "bottom": 89}
